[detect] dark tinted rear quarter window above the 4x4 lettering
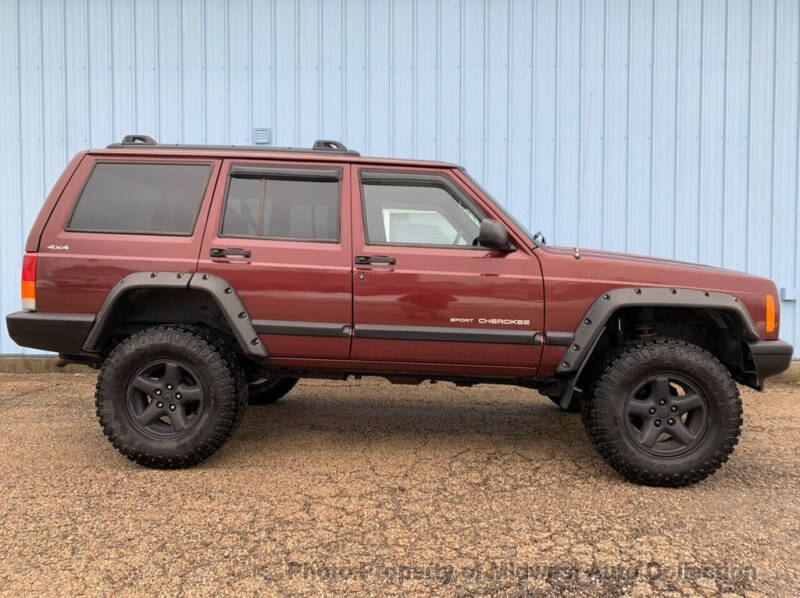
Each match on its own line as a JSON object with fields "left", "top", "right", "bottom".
{"left": 67, "top": 164, "right": 211, "bottom": 235}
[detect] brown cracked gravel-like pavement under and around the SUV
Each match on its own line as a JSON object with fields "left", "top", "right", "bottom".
{"left": 0, "top": 373, "right": 800, "bottom": 596}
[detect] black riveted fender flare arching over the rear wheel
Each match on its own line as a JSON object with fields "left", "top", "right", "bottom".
{"left": 83, "top": 272, "right": 269, "bottom": 360}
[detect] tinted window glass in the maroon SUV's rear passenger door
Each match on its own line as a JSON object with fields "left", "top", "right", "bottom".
{"left": 222, "top": 176, "right": 339, "bottom": 241}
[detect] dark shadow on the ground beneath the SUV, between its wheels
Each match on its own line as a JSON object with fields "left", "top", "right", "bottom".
{"left": 226, "top": 383, "right": 613, "bottom": 475}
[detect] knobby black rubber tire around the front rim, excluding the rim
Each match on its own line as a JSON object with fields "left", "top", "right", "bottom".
{"left": 583, "top": 338, "right": 742, "bottom": 487}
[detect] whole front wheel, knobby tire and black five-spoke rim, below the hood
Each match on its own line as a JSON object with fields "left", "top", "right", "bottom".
{"left": 583, "top": 338, "right": 742, "bottom": 487}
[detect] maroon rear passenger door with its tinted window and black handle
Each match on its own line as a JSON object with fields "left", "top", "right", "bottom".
{"left": 198, "top": 160, "right": 352, "bottom": 359}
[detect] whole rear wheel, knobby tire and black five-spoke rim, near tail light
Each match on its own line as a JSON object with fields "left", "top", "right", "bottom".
{"left": 95, "top": 326, "right": 247, "bottom": 468}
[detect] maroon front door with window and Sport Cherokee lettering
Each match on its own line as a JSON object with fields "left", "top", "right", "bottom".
{"left": 351, "top": 166, "right": 543, "bottom": 375}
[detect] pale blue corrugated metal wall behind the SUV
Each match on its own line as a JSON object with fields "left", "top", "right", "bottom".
{"left": 0, "top": 0, "right": 800, "bottom": 353}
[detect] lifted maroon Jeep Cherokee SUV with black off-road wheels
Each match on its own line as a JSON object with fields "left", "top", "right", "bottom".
{"left": 7, "top": 135, "right": 792, "bottom": 486}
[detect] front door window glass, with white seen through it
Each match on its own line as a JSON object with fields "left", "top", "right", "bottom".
{"left": 362, "top": 182, "right": 480, "bottom": 246}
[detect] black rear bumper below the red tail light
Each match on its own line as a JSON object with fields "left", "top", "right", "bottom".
{"left": 6, "top": 311, "right": 94, "bottom": 355}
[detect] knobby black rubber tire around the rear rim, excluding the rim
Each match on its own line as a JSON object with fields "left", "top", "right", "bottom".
{"left": 95, "top": 325, "right": 247, "bottom": 469}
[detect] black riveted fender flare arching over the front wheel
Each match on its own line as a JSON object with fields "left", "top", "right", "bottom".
{"left": 556, "top": 287, "right": 758, "bottom": 406}
